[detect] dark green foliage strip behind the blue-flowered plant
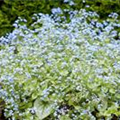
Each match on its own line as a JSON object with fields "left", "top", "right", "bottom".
{"left": 0, "top": 0, "right": 120, "bottom": 36}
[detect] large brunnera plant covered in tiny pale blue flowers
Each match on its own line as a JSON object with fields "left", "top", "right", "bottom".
{"left": 0, "top": 10, "right": 120, "bottom": 120}
